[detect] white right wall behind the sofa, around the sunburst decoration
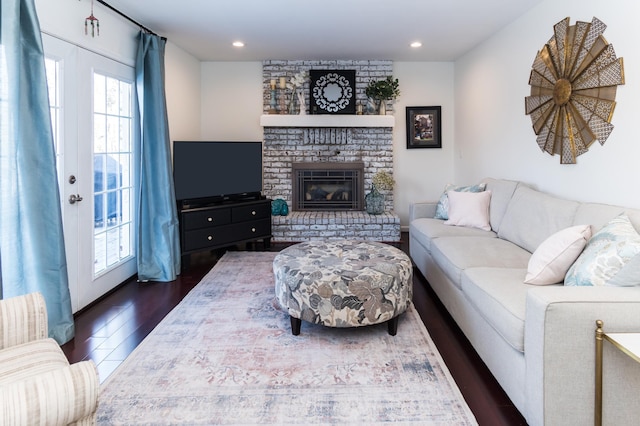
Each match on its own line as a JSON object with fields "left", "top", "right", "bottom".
{"left": 454, "top": 0, "right": 640, "bottom": 208}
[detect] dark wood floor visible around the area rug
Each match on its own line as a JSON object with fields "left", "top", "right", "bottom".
{"left": 62, "top": 233, "right": 526, "bottom": 426}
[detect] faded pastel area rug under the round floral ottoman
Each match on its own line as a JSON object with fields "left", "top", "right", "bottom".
{"left": 98, "top": 252, "right": 477, "bottom": 425}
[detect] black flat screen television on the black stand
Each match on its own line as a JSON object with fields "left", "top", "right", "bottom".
{"left": 173, "top": 141, "right": 262, "bottom": 206}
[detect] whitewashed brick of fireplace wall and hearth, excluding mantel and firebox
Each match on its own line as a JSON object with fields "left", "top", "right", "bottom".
{"left": 263, "top": 61, "right": 400, "bottom": 241}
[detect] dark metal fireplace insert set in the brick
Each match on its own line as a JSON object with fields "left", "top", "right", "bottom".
{"left": 292, "top": 163, "right": 364, "bottom": 211}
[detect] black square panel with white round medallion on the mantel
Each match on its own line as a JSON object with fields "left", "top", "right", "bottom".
{"left": 309, "top": 70, "right": 356, "bottom": 114}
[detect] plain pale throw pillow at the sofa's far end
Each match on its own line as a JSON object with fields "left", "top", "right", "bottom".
{"left": 444, "top": 190, "right": 491, "bottom": 231}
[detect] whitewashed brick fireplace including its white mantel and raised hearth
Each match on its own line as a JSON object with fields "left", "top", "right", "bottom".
{"left": 261, "top": 61, "right": 400, "bottom": 242}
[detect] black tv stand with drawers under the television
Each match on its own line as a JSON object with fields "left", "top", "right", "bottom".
{"left": 178, "top": 196, "right": 271, "bottom": 269}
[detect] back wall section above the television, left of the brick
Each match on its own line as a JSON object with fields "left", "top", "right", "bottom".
{"left": 200, "top": 62, "right": 262, "bottom": 141}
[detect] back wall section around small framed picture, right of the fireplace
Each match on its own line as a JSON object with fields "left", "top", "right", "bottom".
{"left": 393, "top": 62, "right": 455, "bottom": 229}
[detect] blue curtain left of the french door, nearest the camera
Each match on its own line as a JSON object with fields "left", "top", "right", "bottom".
{"left": 0, "top": 0, "right": 74, "bottom": 344}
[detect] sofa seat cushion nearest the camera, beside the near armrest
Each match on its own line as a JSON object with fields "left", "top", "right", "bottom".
{"left": 462, "top": 267, "right": 532, "bottom": 352}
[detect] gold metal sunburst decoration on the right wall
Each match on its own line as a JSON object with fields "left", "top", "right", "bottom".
{"left": 525, "top": 18, "right": 624, "bottom": 164}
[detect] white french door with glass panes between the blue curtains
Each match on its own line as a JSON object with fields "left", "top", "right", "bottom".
{"left": 43, "top": 35, "right": 136, "bottom": 312}
